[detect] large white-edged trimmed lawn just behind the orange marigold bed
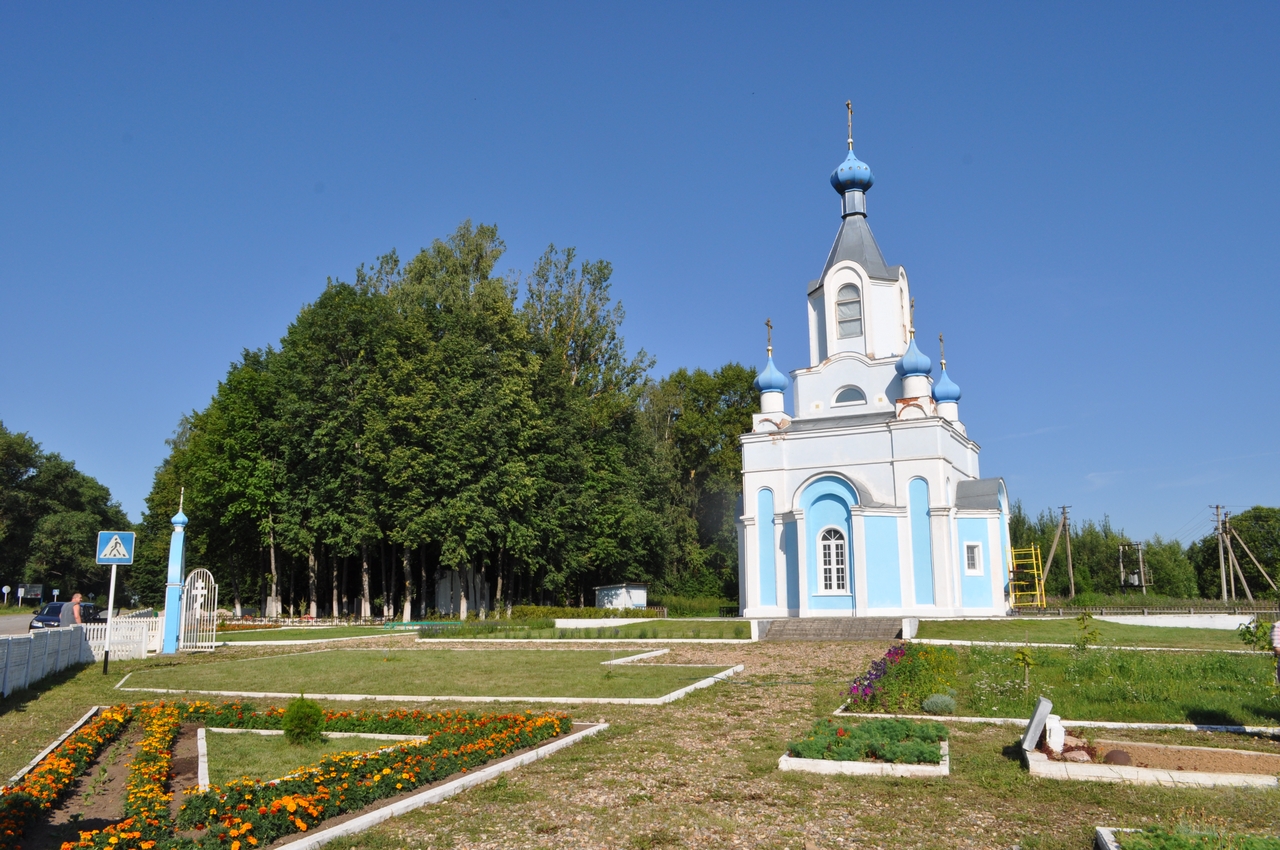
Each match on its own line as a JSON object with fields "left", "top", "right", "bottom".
{"left": 125, "top": 649, "right": 723, "bottom": 699}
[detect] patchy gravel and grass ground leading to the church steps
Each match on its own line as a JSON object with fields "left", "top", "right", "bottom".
{"left": 317, "top": 643, "right": 1280, "bottom": 850}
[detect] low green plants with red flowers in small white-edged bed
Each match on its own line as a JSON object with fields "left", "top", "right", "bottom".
{"left": 787, "top": 718, "right": 947, "bottom": 764}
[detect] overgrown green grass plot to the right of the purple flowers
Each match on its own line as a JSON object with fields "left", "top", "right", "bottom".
{"left": 956, "top": 646, "right": 1280, "bottom": 726}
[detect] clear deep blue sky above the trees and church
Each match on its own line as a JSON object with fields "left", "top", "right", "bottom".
{"left": 0, "top": 1, "right": 1280, "bottom": 540}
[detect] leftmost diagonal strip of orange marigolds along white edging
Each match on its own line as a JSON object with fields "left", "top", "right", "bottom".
{"left": 0, "top": 705, "right": 133, "bottom": 850}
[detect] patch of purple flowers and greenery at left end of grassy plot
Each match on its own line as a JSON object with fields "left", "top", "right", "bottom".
{"left": 847, "top": 644, "right": 959, "bottom": 713}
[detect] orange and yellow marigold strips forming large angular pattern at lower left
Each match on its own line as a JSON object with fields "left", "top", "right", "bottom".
{"left": 26, "top": 702, "right": 572, "bottom": 850}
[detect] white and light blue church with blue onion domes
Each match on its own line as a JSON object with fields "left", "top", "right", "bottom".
{"left": 737, "top": 120, "right": 1009, "bottom": 618}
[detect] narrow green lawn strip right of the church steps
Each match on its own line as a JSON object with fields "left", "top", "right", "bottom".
{"left": 916, "top": 618, "right": 1248, "bottom": 649}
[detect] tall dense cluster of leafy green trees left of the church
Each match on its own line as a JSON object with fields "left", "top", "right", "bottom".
{"left": 133, "top": 223, "right": 756, "bottom": 618}
